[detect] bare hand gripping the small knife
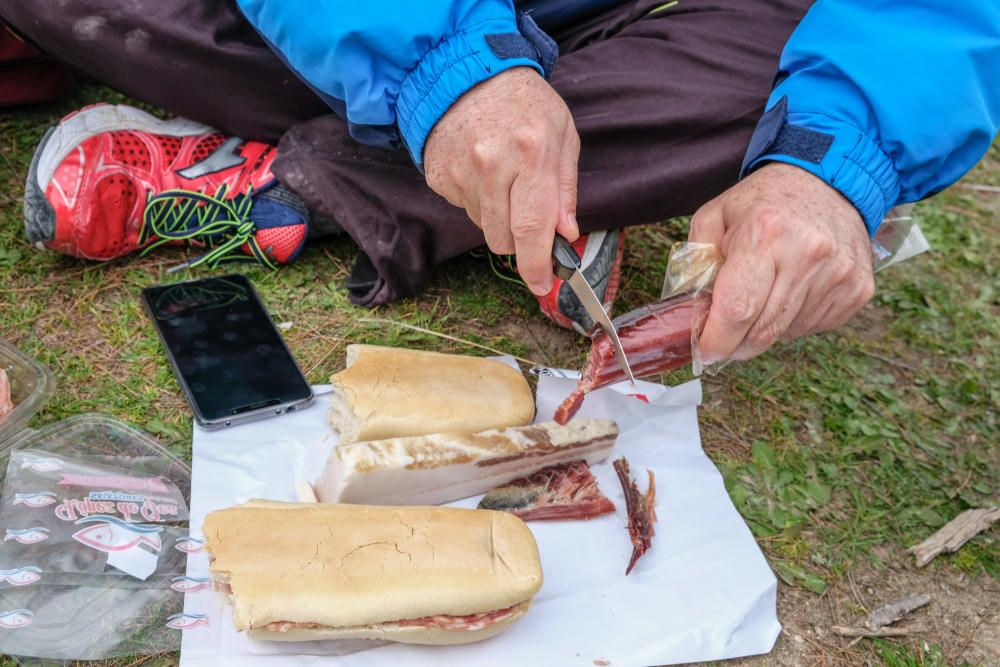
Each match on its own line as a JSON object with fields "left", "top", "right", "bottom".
{"left": 424, "top": 67, "right": 580, "bottom": 294}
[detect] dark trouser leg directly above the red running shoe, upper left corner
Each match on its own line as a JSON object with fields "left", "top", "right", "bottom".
{"left": 0, "top": 0, "right": 330, "bottom": 143}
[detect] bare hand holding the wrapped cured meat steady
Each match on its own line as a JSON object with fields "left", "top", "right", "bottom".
{"left": 689, "top": 163, "right": 875, "bottom": 362}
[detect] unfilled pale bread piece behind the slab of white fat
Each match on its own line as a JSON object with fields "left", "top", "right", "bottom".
{"left": 329, "top": 345, "right": 535, "bottom": 443}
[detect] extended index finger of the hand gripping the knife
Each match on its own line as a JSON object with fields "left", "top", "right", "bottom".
{"left": 510, "top": 160, "right": 559, "bottom": 296}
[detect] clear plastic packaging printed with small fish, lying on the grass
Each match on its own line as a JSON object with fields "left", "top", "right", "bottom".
{"left": 0, "top": 417, "right": 191, "bottom": 660}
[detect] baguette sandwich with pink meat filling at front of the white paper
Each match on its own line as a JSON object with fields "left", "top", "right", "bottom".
{"left": 204, "top": 500, "right": 542, "bottom": 644}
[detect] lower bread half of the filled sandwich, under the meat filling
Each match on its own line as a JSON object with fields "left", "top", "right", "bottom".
{"left": 249, "top": 602, "right": 531, "bottom": 646}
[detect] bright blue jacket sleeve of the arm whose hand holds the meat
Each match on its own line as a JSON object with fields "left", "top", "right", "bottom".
{"left": 741, "top": 0, "right": 1000, "bottom": 235}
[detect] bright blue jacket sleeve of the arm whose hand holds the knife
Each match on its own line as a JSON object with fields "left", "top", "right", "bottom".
{"left": 238, "top": 0, "right": 557, "bottom": 166}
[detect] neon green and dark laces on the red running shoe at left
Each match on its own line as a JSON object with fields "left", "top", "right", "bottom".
{"left": 139, "top": 185, "right": 278, "bottom": 273}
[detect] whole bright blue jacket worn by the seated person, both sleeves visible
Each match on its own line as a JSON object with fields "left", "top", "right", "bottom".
{"left": 238, "top": 0, "right": 1000, "bottom": 234}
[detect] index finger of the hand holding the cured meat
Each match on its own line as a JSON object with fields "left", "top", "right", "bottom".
{"left": 698, "top": 243, "right": 776, "bottom": 363}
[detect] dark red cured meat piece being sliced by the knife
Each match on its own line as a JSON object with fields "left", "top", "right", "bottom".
{"left": 555, "top": 292, "right": 712, "bottom": 424}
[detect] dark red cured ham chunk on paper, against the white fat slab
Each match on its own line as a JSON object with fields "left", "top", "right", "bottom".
{"left": 479, "top": 461, "right": 615, "bottom": 521}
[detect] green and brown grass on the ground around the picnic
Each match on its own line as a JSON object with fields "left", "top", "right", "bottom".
{"left": 0, "top": 87, "right": 1000, "bottom": 665}
